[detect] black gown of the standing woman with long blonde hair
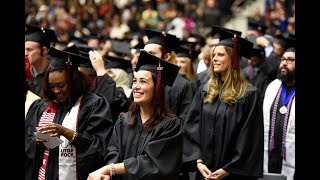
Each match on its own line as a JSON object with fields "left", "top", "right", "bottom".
{"left": 183, "top": 84, "right": 264, "bottom": 180}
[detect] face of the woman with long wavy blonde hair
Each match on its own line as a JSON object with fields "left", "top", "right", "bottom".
{"left": 211, "top": 46, "right": 231, "bottom": 74}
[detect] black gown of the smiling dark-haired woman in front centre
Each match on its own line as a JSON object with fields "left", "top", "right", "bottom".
{"left": 106, "top": 113, "right": 182, "bottom": 180}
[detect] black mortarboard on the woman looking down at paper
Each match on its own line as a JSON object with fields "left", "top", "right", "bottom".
{"left": 47, "top": 47, "right": 90, "bottom": 70}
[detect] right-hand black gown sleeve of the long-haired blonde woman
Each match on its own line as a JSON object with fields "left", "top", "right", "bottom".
{"left": 222, "top": 86, "right": 264, "bottom": 177}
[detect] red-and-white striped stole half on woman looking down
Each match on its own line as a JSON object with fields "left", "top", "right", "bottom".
{"left": 38, "top": 101, "right": 57, "bottom": 180}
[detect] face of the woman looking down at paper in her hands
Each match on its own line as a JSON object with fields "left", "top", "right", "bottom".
{"left": 48, "top": 70, "right": 68, "bottom": 102}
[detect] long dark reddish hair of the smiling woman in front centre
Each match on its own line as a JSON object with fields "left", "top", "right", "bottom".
{"left": 128, "top": 73, "right": 174, "bottom": 131}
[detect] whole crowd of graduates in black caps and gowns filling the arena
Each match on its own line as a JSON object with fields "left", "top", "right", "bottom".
{"left": 25, "top": 0, "right": 295, "bottom": 180}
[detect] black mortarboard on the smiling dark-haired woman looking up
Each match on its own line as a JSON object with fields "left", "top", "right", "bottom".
{"left": 135, "top": 51, "right": 180, "bottom": 86}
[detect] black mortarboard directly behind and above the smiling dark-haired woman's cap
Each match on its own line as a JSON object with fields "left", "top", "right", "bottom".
{"left": 145, "top": 29, "right": 178, "bottom": 53}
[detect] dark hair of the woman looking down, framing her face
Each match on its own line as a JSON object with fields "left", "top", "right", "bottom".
{"left": 42, "top": 68, "right": 93, "bottom": 105}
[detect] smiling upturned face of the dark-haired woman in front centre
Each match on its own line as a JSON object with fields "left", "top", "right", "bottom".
{"left": 132, "top": 70, "right": 154, "bottom": 107}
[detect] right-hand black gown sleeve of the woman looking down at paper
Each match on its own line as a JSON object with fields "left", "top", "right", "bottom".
{"left": 72, "top": 93, "right": 113, "bottom": 177}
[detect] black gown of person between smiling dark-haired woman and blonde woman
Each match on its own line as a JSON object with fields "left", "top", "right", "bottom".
{"left": 165, "top": 74, "right": 194, "bottom": 121}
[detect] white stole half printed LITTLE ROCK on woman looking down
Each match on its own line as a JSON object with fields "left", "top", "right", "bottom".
{"left": 59, "top": 96, "right": 82, "bottom": 180}
